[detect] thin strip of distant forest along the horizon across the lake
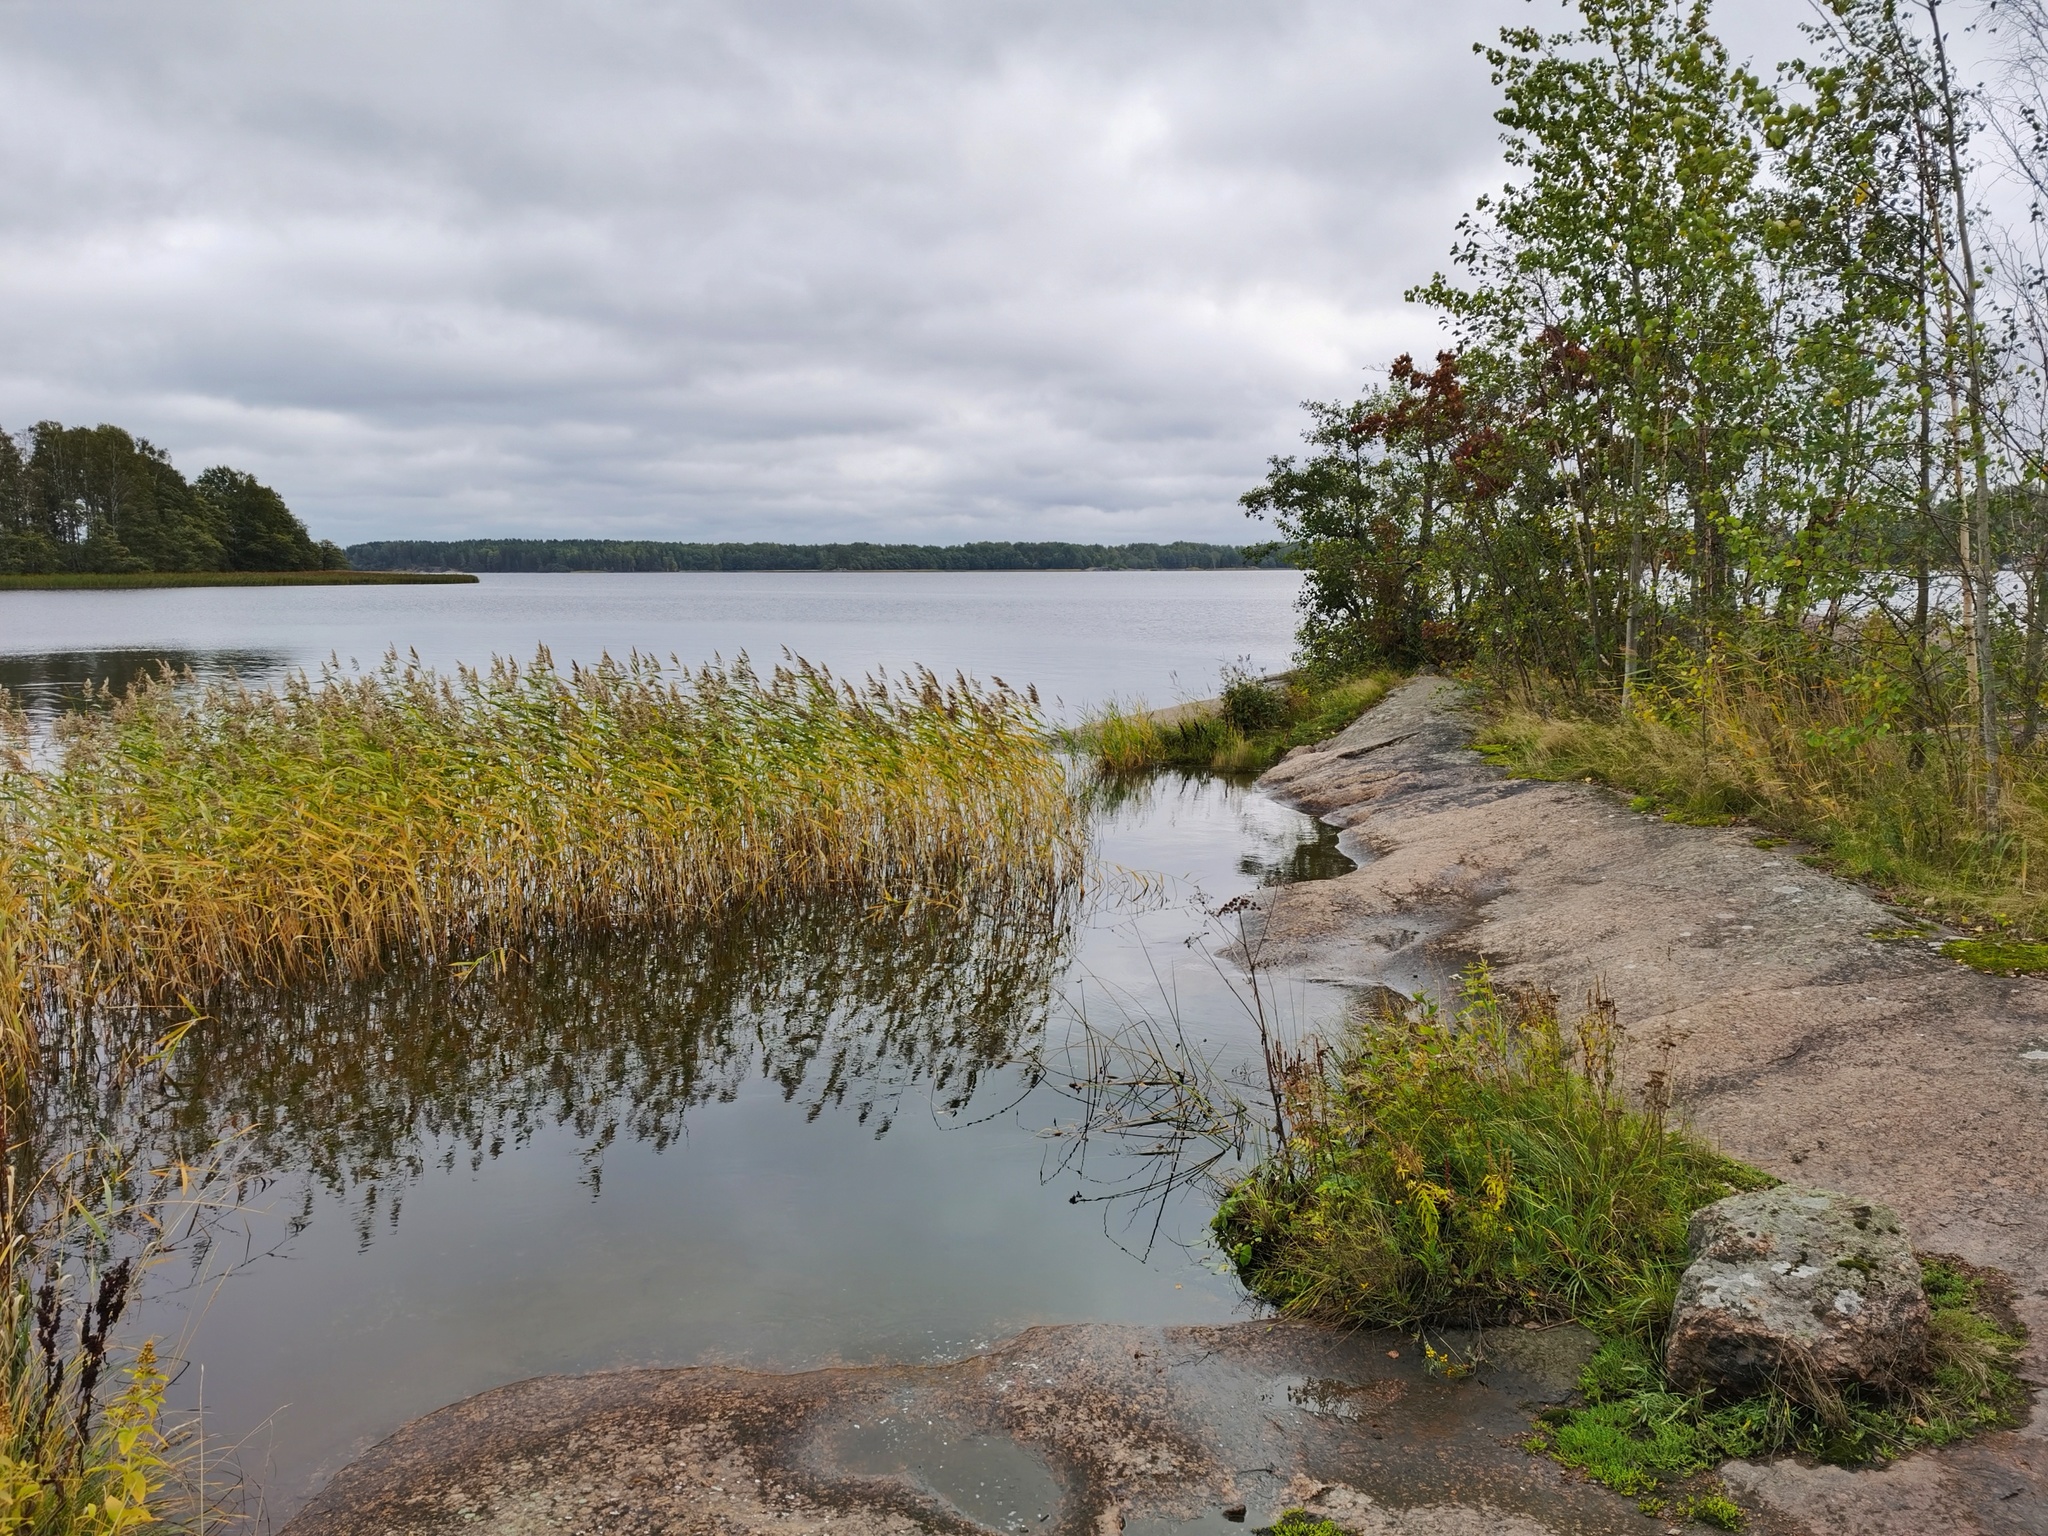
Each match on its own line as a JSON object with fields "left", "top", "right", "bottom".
{"left": 348, "top": 539, "right": 1288, "bottom": 571}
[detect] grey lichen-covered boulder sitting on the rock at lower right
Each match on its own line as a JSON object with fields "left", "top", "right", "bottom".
{"left": 1665, "top": 1184, "right": 1927, "bottom": 1399}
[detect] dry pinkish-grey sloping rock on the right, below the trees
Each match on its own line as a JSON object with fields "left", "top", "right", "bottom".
{"left": 1260, "top": 678, "right": 2048, "bottom": 1536}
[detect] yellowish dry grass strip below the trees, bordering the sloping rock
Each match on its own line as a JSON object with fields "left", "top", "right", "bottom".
{"left": 1477, "top": 659, "right": 2048, "bottom": 950}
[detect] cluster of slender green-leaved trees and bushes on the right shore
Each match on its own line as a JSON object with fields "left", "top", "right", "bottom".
{"left": 1243, "top": 0, "right": 2048, "bottom": 829}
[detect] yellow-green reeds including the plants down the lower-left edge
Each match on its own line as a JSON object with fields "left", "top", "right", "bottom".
{"left": 0, "top": 651, "right": 1085, "bottom": 1536}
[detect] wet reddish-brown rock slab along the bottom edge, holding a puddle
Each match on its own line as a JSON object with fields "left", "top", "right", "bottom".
{"left": 287, "top": 1323, "right": 1645, "bottom": 1536}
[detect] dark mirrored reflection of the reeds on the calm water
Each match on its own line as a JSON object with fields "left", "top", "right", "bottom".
{"left": 139, "top": 888, "right": 1073, "bottom": 1241}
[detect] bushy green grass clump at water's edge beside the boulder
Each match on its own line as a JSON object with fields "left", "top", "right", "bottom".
{"left": 1214, "top": 971, "right": 1769, "bottom": 1331}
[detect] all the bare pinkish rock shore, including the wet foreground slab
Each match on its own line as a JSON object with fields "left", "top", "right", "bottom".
{"left": 287, "top": 678, "right": 2048, "bottom": 1536}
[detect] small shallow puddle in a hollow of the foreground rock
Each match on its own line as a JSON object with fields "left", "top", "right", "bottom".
{"left": 825, "top": 1409, "right": 1063, "bottom": 1532}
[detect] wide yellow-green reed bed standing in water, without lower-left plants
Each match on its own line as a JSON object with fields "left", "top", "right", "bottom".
{"left": 0, "top": 649, "right": 1083, "bottom": 1049}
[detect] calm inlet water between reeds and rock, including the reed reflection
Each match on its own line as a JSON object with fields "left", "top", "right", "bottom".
{"left": 83, "top": 776, "right": 1348, "bottom": 1518}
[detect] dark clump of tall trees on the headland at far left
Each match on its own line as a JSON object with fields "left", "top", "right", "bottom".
{"left": 0, "top": 422, "right": 348, "bottom": 575}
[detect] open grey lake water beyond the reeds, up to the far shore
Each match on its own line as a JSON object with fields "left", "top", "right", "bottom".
{"left": 0, "top": 571, "right": 1300, "bottom": 717}
